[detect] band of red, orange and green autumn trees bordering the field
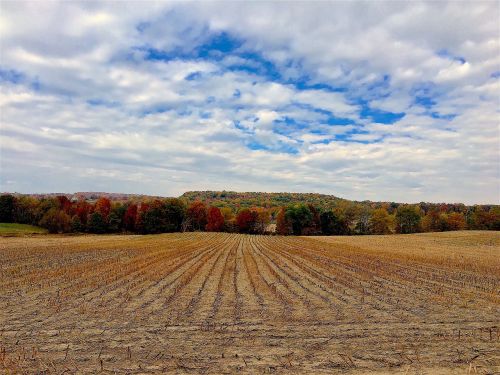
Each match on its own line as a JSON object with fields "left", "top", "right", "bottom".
{"left": 0, "top": 194, "right": 500, "bottom": 235}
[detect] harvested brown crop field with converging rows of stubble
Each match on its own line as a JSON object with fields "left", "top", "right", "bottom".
{"left": 0, "top": 232, "right": 500, "bottom": 374}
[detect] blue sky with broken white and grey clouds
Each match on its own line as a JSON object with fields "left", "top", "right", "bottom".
{"left": 0, "top": 0, "right": 500, "bottom": 204}
